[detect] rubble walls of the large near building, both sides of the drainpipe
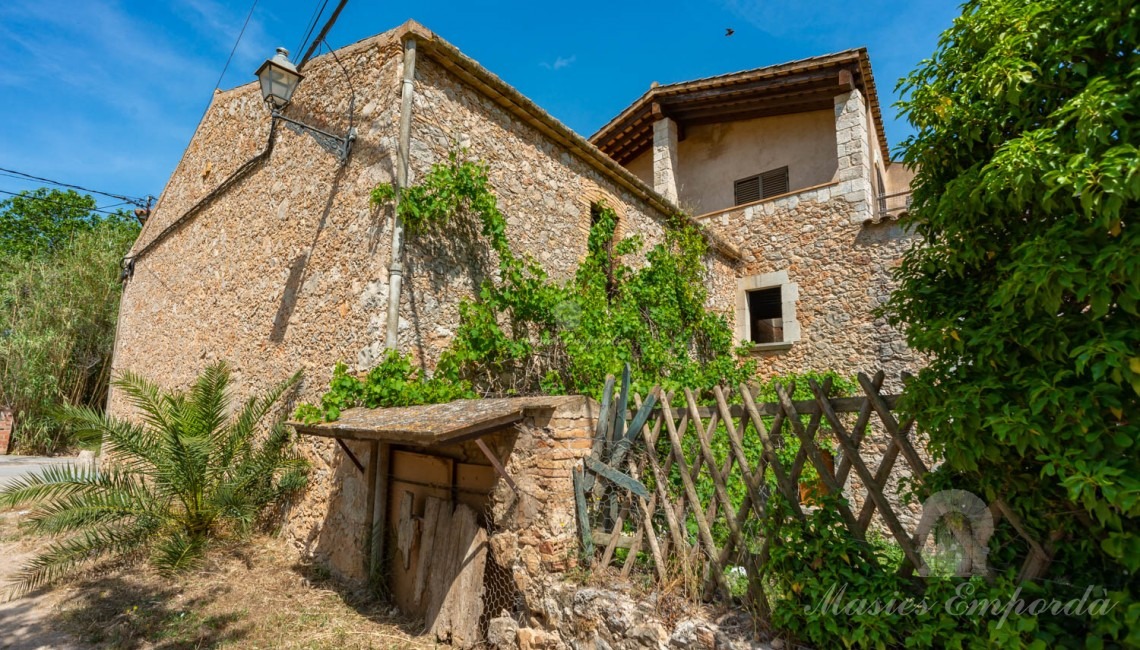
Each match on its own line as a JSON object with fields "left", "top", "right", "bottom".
{"left": 111, "top": 27, "right": 727, "bottom": 576}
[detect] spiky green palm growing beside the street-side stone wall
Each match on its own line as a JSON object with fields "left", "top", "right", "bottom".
{"left": 0, "top": 363, "right": 308, "bottom": 593}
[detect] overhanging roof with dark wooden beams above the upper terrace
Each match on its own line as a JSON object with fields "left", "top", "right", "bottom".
{"left": 589, "top": 48, "right": 890, "bottom": 164}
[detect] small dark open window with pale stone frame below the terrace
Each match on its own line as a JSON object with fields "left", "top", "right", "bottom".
{"left": 736, "top": 271, "right": 799, "bottom": 349}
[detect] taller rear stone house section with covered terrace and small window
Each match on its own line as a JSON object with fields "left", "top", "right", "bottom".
{"left": 591, "top": 48, "right": 917, "bottom": 387}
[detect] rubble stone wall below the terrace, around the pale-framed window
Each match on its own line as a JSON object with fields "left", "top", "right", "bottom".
{"left": 703, "top": 184, "right": 919, "bottom": 391}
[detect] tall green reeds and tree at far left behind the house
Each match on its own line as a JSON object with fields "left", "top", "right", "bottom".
{"left": 0, "top": 189, "right": 139, "bottom": 453}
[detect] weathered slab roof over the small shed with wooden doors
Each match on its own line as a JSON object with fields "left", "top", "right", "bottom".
{"left": 290, "top": 396, "right": 583, "bottom": 447}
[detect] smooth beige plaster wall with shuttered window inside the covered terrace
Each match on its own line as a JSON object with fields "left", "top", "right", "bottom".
{"left": 627, "top": 111, "right": 837, "bottom": 214}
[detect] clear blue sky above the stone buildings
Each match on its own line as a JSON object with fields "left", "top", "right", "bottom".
{"left": 0, "top": 0, "right": 959, "bottom": 204}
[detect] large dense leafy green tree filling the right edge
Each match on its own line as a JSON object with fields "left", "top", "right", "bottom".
{"left": 887, "top": 0, "right": 1140, "bottom": 647}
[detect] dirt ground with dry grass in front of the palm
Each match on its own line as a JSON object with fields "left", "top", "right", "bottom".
{"left": 0, "top": 511, "right": 446, "bottom": 650}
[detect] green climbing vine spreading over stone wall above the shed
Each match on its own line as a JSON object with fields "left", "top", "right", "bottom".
{"left": 298, "top": 153, "right": 756, "bottom": 421}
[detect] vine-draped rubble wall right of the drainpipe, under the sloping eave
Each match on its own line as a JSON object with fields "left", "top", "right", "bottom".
{"left": 396, "top": 57, "right": 733, "bottom": 365}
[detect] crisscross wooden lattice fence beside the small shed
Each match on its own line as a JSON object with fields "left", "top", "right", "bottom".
{"left": 573, "top": 368, "right": 1049, "bottom": 611}
